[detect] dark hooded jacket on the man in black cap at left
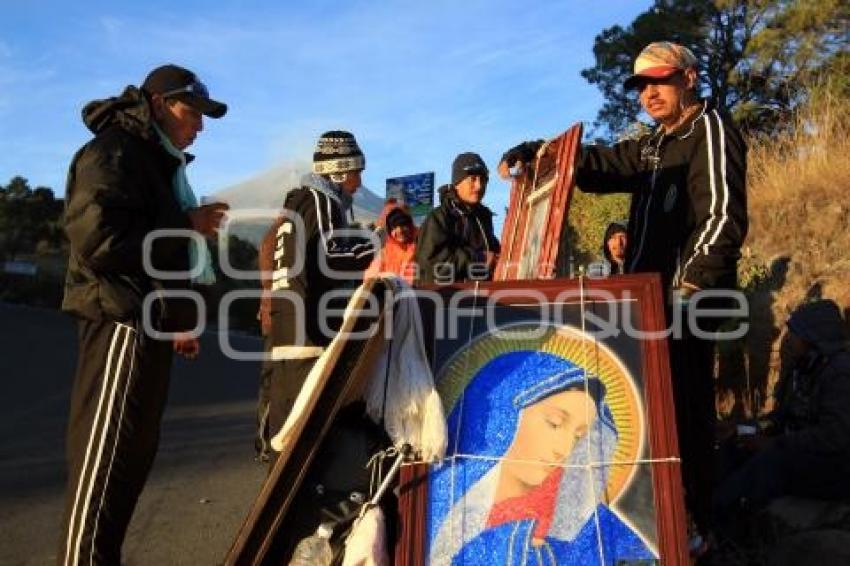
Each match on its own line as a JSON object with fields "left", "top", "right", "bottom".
{"left": 62, "top": 86, "right": 195, "bottom": 330}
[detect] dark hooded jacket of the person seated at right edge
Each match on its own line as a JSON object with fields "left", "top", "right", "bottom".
{"left": 770, "top": 300, "right": 850, "bottom": 460}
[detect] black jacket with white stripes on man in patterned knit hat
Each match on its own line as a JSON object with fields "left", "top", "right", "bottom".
{"left": 271, "top": 176, "right": 375, "bottom": 359}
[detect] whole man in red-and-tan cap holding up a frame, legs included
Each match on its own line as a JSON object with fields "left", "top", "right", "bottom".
{"left": 499, "top": 42, "right": 747, "bottom": 544}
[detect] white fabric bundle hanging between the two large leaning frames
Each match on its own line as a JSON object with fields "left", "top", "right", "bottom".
{"left": 365, "top": 277, "right": 448, "bottom": 462}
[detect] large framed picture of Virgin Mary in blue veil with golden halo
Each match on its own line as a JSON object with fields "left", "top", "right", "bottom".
{"left": 396, "top": 275, "right": 688, "bottom": 566}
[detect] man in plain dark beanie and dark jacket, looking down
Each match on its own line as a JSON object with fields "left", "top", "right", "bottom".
{"left": 416, "top": 153, "right": 501, "bottom": 284}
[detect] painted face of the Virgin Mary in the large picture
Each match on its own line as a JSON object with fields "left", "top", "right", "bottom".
{"left": 500, "top": 389, "right": 596, "bottom": 495}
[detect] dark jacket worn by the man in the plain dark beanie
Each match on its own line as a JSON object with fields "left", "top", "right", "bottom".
{"left": 416, "top": 187, "right": 501, "bottom": 283}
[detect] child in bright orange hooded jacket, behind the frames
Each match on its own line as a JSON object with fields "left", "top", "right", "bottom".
{"left": 364, "top": 204, "right": 418, "bottom": 283}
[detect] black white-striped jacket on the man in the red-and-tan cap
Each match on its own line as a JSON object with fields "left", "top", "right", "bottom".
{"left": 576, "top": 102, "right": 747, "bottom": 296}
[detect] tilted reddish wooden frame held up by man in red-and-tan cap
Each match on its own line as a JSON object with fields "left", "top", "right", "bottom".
{"left": 495, "top": 123, "right": 582, "bottom": 281}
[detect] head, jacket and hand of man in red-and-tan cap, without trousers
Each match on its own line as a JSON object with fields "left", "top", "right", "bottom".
{"left": 499, "top": 42, "right": 747, "bottom": 295}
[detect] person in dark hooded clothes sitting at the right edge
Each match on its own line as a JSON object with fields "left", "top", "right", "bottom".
{"left": 713, "top": 300, "right": 850, "bottom": 519}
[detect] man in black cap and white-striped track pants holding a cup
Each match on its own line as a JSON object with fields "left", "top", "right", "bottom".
{"left": 57, "top": 65, "right": 227, "bottom": 564}
